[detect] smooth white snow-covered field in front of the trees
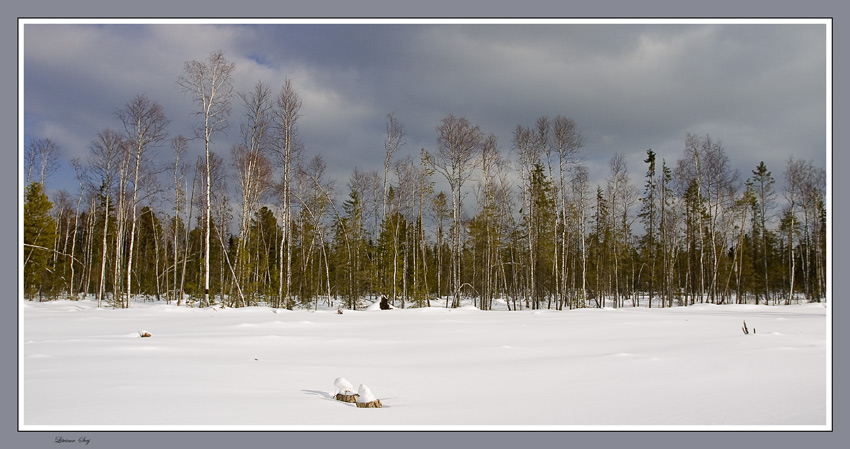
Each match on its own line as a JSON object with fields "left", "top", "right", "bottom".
{"left": 19, "top": 300, "right": 832, "bottom": 430}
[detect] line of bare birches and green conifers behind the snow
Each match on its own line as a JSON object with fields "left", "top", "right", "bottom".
{"left": 22, "top": 52, "right": 827, "bottom": 310}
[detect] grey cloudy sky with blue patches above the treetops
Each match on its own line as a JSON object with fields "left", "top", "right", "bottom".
{"left": 22, "top": 22, "right": 827, "bottom": 203}
